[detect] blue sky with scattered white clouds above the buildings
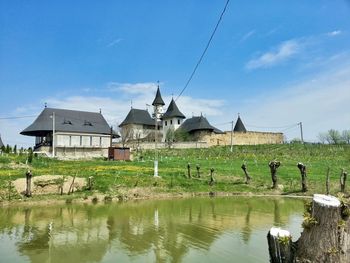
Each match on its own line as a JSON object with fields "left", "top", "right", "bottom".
{"left": 0, "top": 0, "right": 350, "bottom": 146}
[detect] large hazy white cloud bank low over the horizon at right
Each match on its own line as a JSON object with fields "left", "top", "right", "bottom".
{"left": 239, "top": 56, "right": 350, "bottom": 141}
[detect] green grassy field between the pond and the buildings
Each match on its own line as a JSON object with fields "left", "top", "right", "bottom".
{"left": 0, "top": 144, "right": 350, "bottom": 202}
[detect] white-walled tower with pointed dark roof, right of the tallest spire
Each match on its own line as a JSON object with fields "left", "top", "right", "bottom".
{"left": 162, "top": 99, "right": 186, "bottom": 142}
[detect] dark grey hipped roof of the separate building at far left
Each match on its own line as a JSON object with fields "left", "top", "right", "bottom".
{"left": 21, "top": 108, "right": 110, "bottom": 136}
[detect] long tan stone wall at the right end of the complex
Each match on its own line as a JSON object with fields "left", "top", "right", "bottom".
{"left": 202, "top": 131, "right": 283, "bottom": 146}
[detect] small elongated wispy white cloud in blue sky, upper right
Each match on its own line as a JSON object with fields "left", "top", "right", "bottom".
{"left": 246, "top": 39, "right": 302, "bottom": 69}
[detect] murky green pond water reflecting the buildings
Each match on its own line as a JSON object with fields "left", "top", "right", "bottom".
{"left": 0, "top": 197, "right": 304, "bottom": 263}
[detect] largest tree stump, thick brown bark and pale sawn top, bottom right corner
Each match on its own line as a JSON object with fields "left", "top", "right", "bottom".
{"left": 296, "top": 194, "right": 350, "bottom": 263}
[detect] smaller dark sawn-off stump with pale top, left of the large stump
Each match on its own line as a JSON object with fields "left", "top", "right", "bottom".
{"left": 267, "top": 227, "right": 294, "bottom": 263}
